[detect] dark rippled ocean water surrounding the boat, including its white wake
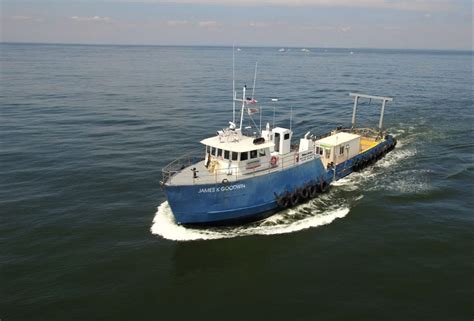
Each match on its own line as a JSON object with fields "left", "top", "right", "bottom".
{"left": 0, "top": 44, "right": 474, "bottom": 321}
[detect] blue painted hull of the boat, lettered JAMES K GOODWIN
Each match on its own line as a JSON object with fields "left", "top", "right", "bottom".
{"left": 165, "top": 138, "right": 393, "bottom": 225}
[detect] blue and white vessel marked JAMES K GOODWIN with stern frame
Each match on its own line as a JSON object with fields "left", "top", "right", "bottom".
{"left": 161, "top": 81, "right": 397, "bottom": 225}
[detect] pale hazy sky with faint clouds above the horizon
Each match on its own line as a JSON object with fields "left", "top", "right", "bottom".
{"left": 0, "top": 0, "right": 473, "bottom": 50}
